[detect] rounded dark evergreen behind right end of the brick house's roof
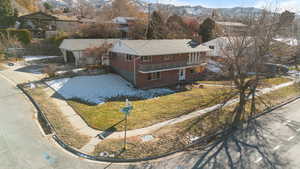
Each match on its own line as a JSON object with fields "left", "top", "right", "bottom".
{"left": 198, "top": 18, "right": 216, "bottom": 42}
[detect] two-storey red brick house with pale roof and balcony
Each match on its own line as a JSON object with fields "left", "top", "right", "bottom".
{"left": 110, "top": 39, "right": 210, "bottom": 89}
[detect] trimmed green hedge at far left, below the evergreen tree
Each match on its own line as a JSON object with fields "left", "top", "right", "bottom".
{"left": 0, "top": 29, "right": 32, "bottom": 45}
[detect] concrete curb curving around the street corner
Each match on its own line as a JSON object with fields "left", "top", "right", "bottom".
{"left": 17, "top": 84, "right": 300, "bottom": 163}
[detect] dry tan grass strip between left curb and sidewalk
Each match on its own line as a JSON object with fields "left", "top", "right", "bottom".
{"left": 28, "top": 87, "right": 90, "bottom": 149}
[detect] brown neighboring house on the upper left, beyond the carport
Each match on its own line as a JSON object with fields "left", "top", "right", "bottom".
{"left": 19, "top": 12, "right": 80, "bottom": 38}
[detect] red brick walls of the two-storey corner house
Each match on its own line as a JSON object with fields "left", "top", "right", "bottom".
{"left": 110, "top": 53, "right": 209, "bottom": 89}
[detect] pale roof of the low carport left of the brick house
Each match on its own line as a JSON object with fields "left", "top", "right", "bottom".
{"left": 59, "top": 39, "right": 118, "bottom": 51}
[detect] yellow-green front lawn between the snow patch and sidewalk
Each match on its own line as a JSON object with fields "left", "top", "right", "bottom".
{"left": 68, "top": 87, "right": 226, "bottom": 130}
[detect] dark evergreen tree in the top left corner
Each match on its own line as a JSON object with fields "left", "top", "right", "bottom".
{"left": 0, "top": 0, "right": 16, "bottom": 27}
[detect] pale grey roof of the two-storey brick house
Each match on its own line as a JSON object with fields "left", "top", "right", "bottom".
{"left": 112, "top": 39, "right": 211, "bottom": 56}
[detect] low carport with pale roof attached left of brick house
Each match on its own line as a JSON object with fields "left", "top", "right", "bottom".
{"left": 59, "top": 39, "right": 118, "bottom": 66}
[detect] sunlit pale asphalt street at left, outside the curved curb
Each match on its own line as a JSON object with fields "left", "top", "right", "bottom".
{"left": 0, "top": 76, "right": 127, "bottom": 169}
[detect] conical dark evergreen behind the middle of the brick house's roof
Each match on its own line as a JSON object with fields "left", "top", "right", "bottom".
{"left": 147, "top": 11, "right": 166, "bottom": 39}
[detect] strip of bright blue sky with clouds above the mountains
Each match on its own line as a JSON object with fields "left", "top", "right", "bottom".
{"left": 151, "top": 0, "right": 300, "bottom": 13}
